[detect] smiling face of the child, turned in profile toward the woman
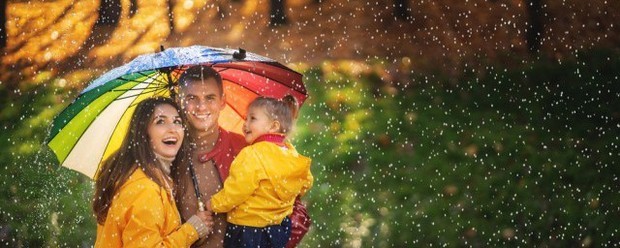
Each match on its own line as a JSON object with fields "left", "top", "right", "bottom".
{"left": 243, "top": 107, "right": 279, "bottom": 144}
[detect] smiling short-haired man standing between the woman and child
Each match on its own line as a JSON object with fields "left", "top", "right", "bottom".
{"left": 175, "top": 66, "right": 310, "bottom": 247}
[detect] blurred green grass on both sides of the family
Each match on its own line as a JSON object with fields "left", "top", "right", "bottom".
{"left": 0, "top": 50, "right": 620, "bottom": 247}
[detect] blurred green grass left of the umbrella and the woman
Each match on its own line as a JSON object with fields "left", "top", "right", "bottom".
{"left": 0, "top": 81, "right": 96, "bottom": 247}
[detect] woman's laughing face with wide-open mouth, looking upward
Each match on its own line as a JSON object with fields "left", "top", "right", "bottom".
{"left": 147, "top": 104, "right": 184, "bottom": 158}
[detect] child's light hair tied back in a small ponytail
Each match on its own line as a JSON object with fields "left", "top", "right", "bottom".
{"left": 248, "top": 95, "right": 299, "bottom": 134}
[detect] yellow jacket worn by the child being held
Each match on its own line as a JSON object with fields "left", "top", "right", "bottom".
{"left": 211, "top": 141, "right": 313, "bottom": 227}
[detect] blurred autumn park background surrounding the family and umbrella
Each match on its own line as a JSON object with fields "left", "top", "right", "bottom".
{"left": 0, "top": 0, "right": 620, "bottom": 247}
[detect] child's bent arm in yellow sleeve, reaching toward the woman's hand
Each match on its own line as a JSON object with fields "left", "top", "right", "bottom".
{"left": 207, "top": 147, "right": 264, "bottom": 213}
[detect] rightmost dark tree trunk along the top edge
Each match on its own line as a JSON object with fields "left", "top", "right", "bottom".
{"left": 525, "top": 0, "right": 544, "bottom": 53}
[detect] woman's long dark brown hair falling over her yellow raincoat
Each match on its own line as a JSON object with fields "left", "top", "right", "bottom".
{"left": 93, "top": 97, "right": 189, "bottom": 224}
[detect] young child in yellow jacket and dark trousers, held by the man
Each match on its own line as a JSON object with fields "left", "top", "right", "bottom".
{"left": 206, "top": 95, "right": 312, "bottom": 247}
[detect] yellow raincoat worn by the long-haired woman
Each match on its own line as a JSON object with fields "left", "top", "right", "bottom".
{"left": 95, "top": 169, "right": 198, "bottom": 247}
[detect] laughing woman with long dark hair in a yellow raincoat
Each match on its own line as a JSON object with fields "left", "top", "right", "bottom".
{"left": 93, "top": 98, "right": 213, "bottom": 247}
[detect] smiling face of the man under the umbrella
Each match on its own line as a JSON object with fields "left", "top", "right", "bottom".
{"left": 180, "top": 78, "right": 225, "bottom": 134}
